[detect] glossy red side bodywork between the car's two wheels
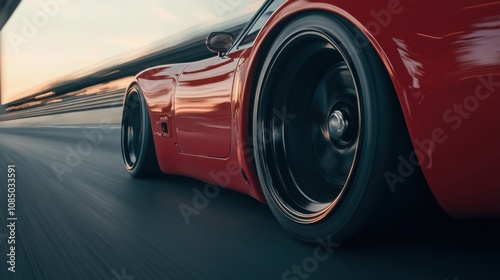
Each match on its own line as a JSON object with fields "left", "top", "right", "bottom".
{"left": 136, "top": 50, "right": 265, "bottom": 202}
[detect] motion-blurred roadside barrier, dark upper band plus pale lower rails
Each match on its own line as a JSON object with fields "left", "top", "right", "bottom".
{"left": 0, "top": 17, "right": 246, "bottom": 121}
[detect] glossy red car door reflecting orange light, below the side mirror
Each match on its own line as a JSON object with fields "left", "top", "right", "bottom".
{"left": 175, "top": 51, "right": 241, "bottom": 158}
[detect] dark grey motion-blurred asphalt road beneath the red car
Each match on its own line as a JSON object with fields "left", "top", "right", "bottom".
{"left": 0, "top": 127, "right": 500, "bottom": 280}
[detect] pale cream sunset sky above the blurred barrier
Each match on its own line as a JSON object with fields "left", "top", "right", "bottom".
{"left": 0, "top": 0, "right": 263, "bottom": 103}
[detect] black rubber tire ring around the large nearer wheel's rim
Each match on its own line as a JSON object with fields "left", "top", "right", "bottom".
{"left": 253, "top": 14, "right": 400, "bottom": 241}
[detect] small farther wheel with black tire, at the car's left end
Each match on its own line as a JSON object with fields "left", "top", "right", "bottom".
{"left": 121, "top": 85, "right": 161, "bottom": 178}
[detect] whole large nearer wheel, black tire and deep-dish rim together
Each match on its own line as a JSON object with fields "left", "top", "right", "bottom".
{"left": 252, "top": 14, "right": 411, "bottom": 243}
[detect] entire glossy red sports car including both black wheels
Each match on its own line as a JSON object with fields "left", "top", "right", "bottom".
{"left": 122, "top": 0, "right": 500, "bottom": 242}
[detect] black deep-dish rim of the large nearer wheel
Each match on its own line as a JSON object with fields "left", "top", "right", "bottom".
{"left": 256, "top": 30, "right": 362, "bottom": 224}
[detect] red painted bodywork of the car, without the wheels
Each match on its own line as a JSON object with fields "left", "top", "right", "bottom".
{"left": 127, "top": 0, "right": 500, "bottom": 217}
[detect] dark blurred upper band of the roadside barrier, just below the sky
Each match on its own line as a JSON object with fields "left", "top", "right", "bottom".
{"left": 1, "top": 17, "right": 247, "bottom": 107}
